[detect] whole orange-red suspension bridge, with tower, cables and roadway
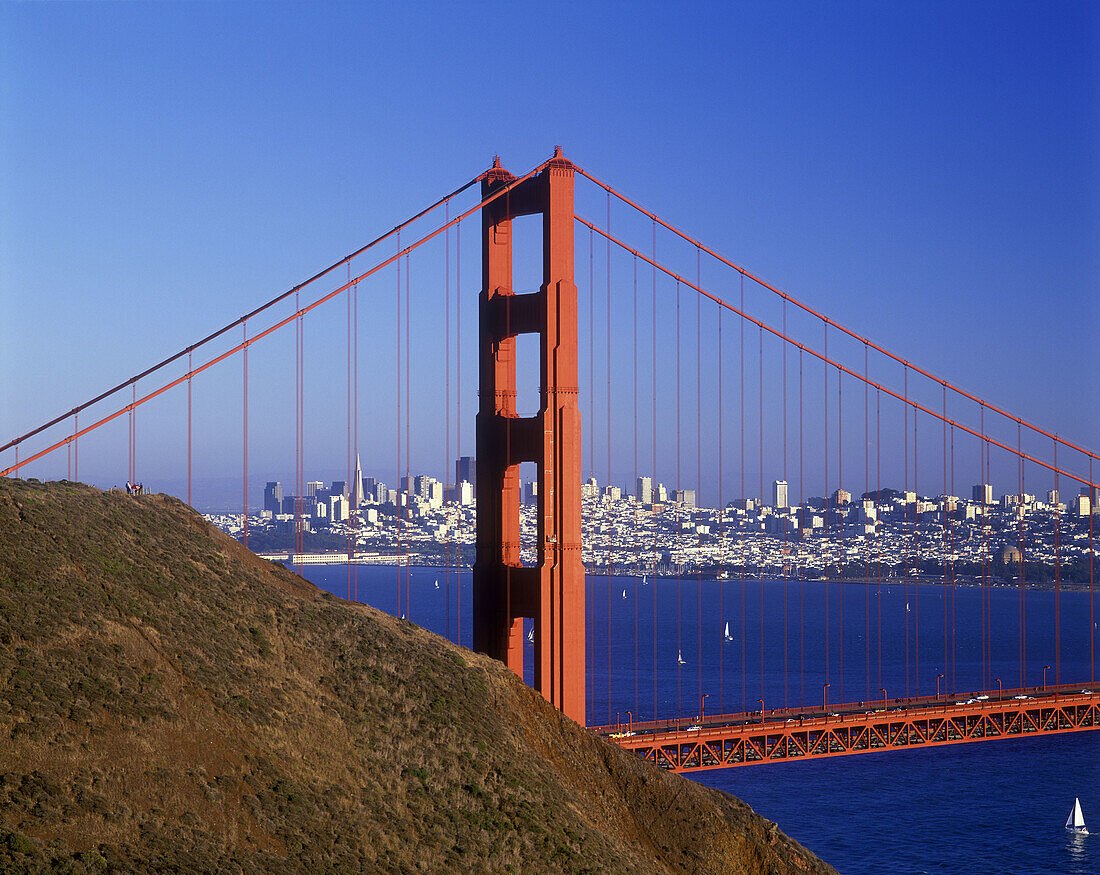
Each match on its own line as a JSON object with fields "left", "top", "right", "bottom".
{"left": 0, "top": 147, "right": 1100, "bottom": 770}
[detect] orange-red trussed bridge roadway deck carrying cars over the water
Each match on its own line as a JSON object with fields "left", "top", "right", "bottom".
{"left": 591, "top": 683, "right": 1100, "bottom": 772}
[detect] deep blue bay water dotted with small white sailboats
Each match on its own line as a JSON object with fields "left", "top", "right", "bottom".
{"left": 301, "top": 565, "right": 1100, "bottom": 873}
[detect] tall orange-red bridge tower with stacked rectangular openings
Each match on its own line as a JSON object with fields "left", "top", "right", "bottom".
{"left": 473, "top": 146, "right": 585, "bottom": 725}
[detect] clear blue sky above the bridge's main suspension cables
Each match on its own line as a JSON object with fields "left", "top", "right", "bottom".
{"left": 0, "top": 2, "right": 1100, "bottom": 504}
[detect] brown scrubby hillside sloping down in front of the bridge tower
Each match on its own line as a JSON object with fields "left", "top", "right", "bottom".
{"left": 0, "top": 479, "right": 833, "bottom": 873}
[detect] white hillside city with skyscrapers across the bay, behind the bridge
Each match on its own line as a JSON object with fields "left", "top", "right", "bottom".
{"left": 209, "top": 457, "right": 1100, "bottom": 584}
